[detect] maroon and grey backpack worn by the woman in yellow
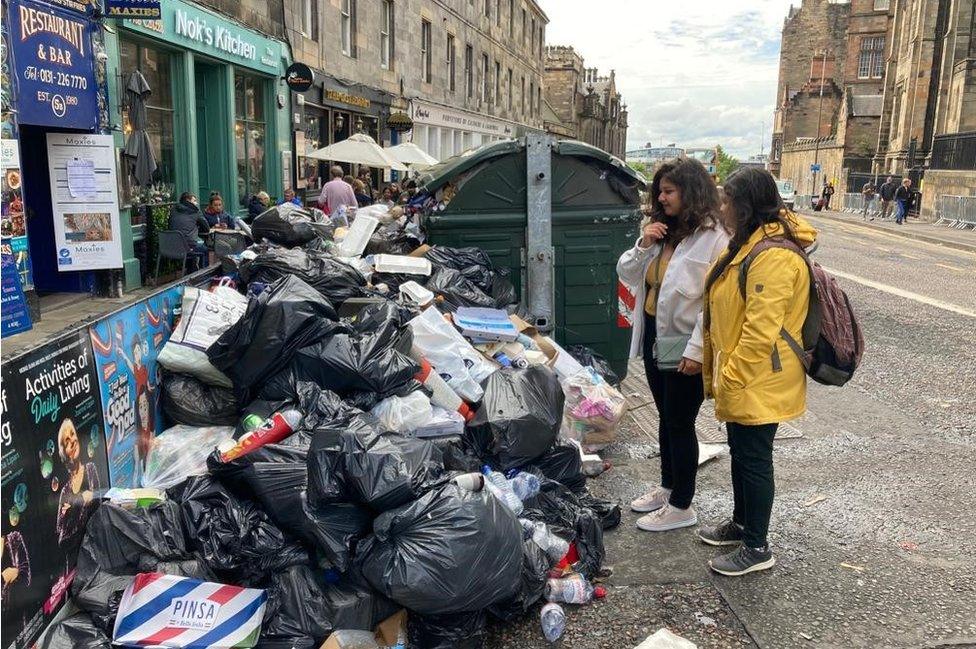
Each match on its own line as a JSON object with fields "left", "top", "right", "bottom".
{"left": 739, "top": 237, "right": 864, "bottom": 385}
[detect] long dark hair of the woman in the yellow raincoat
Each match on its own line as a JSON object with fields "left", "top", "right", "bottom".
{"left": 705, "top": 167, "right": 797, "bottom": 290}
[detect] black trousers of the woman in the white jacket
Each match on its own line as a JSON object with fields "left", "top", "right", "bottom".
{"left": 643, "top": 314, "right": 705, "bottom": 509}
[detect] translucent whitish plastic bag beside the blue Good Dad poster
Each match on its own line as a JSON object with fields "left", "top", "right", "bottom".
{"left": 142, "top": 425, "right": 234, "bottom": 489}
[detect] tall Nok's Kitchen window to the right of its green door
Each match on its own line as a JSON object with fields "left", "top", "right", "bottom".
{"left": 234, "top": 74, "right": 267, "bottom": 205}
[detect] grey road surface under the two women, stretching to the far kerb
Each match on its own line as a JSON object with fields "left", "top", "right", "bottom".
{"left": 488, "top": 217, "right": 976, "bottom": 649}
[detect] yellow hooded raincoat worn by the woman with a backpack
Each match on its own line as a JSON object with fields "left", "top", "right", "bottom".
{"left": 702, "top": 213, "right": 817, "bottom": 425}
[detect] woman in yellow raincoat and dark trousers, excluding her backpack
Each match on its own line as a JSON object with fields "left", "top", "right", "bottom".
{"left": 698, "top": 168, "right": 817, "bottom": 576}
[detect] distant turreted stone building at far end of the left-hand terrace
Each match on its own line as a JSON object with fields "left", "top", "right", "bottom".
{"left": 545, "top": 46, "right": 627, "bottom": 159}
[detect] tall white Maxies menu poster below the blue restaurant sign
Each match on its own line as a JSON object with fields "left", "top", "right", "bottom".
{"left": 47, "top": 133, "right": 122, "bottom": 272}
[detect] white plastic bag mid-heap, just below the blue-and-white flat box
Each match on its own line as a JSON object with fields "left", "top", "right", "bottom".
{"left": 410, "top": 307, "right": 497, "bottom": 403}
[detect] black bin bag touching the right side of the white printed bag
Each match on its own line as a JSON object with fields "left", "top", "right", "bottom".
{"left": 207, "top": 276, "right": 345, "bottom": 403}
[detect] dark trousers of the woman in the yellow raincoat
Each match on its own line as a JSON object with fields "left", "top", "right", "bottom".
{"left": 725, "top": 421, "right": 779, "bottom": 548}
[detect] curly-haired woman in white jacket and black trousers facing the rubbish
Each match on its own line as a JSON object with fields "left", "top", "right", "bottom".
{"left": 617, "top": 158, "right": 729, "bottom": 532}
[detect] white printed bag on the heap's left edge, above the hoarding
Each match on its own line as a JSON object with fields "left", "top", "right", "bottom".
{"left": 158, "top": 286, "right": 247, "bottom": 388}
